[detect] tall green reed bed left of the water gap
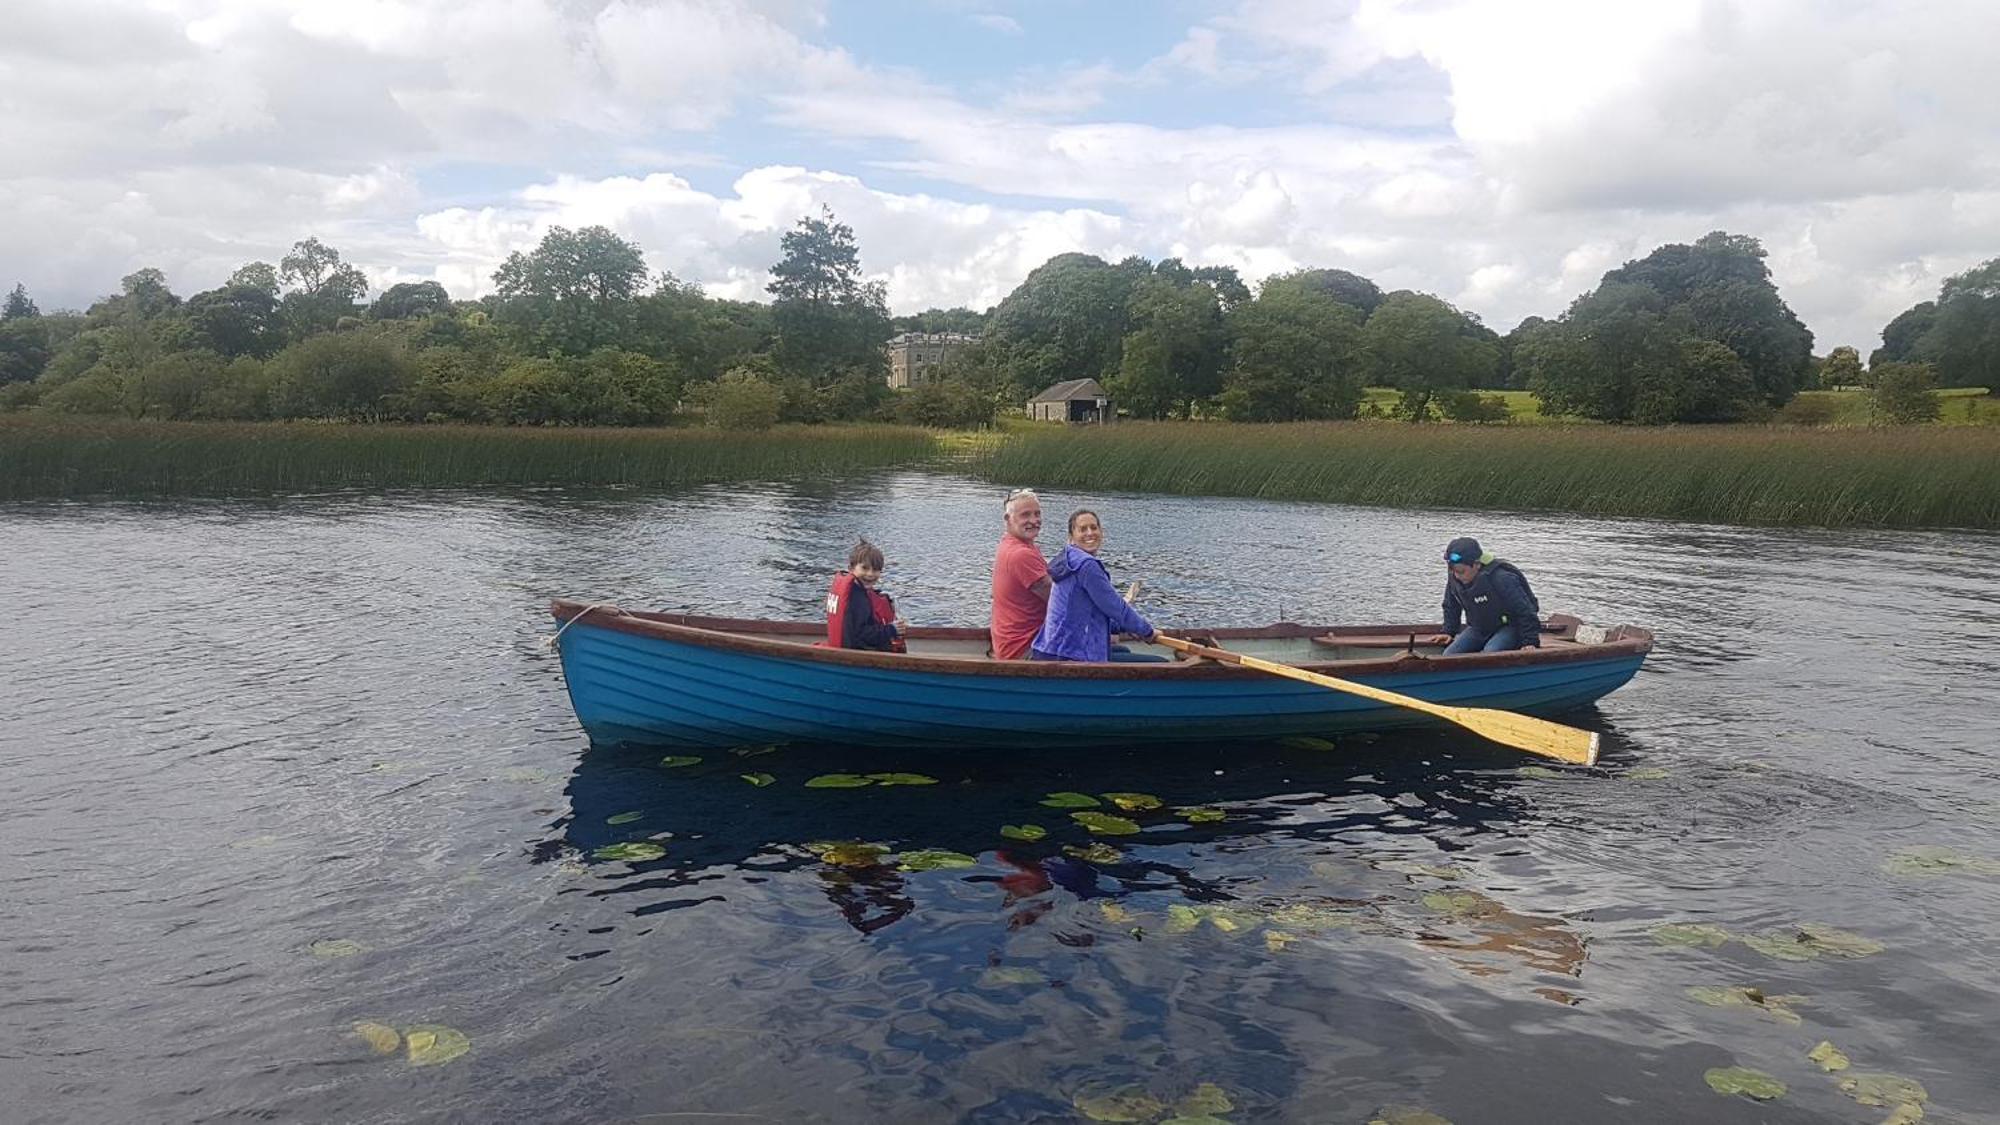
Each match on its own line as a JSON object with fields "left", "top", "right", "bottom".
{"left": 0, "top": 414, "right": 938, "bottom": 498}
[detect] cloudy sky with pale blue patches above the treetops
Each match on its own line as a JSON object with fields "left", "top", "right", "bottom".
{"left": 0, "top": 0, "right": 2000, "bottom": 346}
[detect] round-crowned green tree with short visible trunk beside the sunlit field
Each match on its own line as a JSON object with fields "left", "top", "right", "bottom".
{"left": 1360, "top": 290, "right": 1500, "bottom": 422}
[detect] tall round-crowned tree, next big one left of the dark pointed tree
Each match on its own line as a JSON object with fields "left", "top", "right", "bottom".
{"left": 494, "top": 226, "right": 646, "bottom": 356}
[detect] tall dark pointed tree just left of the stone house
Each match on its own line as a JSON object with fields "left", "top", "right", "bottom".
{"left": 764, "top": 206, "right": 890, "bottom": 386}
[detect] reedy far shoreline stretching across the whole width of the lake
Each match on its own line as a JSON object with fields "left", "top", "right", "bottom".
{"left": 0, "top": 414, "right": 2000, "bottom": 530}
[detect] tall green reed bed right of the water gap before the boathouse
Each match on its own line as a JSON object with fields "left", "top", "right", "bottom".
{"left": 972, "top": 422, "right": 2000, "bottom": 528}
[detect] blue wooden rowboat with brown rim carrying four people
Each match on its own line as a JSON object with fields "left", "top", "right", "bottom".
{"left": 550, "top": 601, "right": 1652, "bottom": 749}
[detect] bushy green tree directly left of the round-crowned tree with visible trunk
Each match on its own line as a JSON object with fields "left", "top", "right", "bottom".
{"left": 1222, "top": 274, "right": 1362, "bottom": 422}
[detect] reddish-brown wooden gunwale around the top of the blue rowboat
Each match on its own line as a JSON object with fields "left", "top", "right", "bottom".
{"left": 548, "top": 599, "right": 1652, "bottom": 681}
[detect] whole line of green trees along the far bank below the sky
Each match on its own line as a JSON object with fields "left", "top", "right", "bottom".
{"left": 0, "top": 208, "right": 2000, "bottom": 426}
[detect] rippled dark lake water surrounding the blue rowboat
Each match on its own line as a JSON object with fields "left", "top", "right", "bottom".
{"left": 0, "top": 474, "right": 2000, "bottom": 1125}
